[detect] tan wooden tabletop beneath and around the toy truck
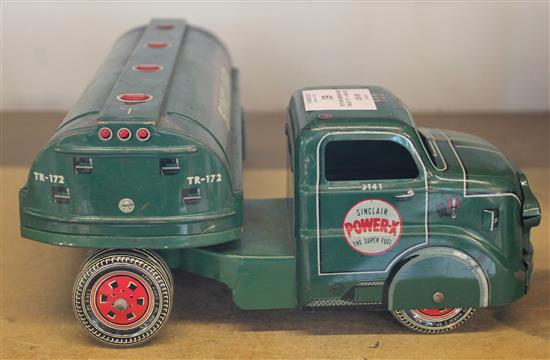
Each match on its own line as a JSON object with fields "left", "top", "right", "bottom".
{"left": 0, "top": 113, "right": 550, "bottom": 359}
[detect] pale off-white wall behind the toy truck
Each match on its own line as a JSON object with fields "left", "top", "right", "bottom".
{"left": 2, "top": 2, "right": 549, "bottom": 111}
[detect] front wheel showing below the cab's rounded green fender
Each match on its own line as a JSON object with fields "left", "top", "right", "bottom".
{"left": 392, "top": 308, "right": 475, "bottom": 334}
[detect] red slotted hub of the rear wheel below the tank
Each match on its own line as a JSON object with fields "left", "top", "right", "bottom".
{"left": 91, "top": 272, "right": 153, "bottom": 328}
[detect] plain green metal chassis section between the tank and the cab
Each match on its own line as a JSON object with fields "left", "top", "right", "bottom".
{"left": 161, "top": 199, "right": 297, "bottom": 309}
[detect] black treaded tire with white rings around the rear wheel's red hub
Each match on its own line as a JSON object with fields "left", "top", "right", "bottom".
{"left": 73, "top": 250, "right": 173, "bottom": 346}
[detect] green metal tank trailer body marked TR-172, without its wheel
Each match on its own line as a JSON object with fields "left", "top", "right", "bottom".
{"left": 20, "top": 19, "right": 243, "bottom": 249}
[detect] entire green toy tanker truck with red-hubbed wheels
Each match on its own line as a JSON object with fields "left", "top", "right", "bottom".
{"left": 20, "top": 20, "right": 540, "bottom": 345}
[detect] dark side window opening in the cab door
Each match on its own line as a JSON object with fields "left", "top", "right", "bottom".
{"left": 325, "top": 140, "right": 419, "bottom": 181}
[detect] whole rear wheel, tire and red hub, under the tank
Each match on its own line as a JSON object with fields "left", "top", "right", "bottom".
{"left": 73, "top": 250, "right": 173, "bottom": 346}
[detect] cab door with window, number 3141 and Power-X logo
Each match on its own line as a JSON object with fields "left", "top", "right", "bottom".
{"left": 317, "top": 131, "right": 428, "bottom": 275}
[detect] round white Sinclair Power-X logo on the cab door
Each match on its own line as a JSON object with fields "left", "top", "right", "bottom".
{"left": 342, "top": 199, "right": 403, "bottom": 255}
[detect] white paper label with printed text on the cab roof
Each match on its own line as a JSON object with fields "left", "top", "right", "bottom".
{"left": 302, "top": 89, "right": 376, "bottom": 111}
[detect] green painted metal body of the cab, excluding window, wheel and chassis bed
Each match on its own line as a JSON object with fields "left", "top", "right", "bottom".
{"left": 287, "top": 86, "right": 540, "bottom": 309}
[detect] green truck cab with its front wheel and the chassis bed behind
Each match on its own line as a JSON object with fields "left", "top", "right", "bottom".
{"left": 179, "top": 86, "right": 540, "bottom": 333}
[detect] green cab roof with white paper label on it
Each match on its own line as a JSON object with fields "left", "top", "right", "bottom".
{"left": 289, "top": 85, "right": 415, "bottom": 138}
